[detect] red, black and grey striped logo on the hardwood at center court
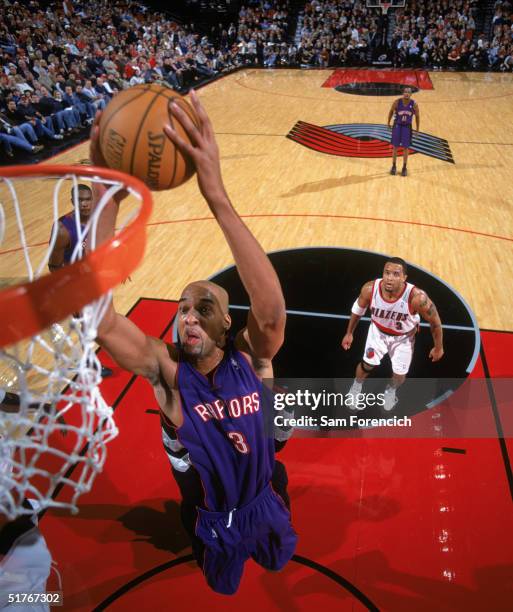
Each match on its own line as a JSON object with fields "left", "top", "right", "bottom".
{"left": 287, "top": 121, "right": 454, "bottom": 164}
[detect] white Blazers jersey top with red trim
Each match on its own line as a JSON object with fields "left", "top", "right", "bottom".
{"left": 370, "top": 278, "right": 420, "bottom": 336}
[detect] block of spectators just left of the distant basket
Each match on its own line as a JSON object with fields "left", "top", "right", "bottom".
{"left": 298, "top": 0, "right": 380, "bottom": 68}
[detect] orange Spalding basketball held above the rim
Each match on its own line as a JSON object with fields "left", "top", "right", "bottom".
{"left": 99, "top": 83, "right": 199, "bottom": 191}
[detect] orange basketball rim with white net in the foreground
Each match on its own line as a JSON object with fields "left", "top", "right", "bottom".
{"left": 0, "top": 166, "right": 151, "bottom": 520}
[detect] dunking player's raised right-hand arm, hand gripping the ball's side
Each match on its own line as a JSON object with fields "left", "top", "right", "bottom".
{"left": 164, "top": 91, "right": 286, "bottom": 359}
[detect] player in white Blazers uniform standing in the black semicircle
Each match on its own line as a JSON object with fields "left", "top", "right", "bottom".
{"left": 342, "top": 257, "right": 444, "bottom": 410}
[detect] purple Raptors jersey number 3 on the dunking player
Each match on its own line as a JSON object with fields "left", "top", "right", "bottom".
{"left": 176, "top": 342, "right": 274, "bottom": 512}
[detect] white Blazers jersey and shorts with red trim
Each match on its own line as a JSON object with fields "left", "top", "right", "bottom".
{"left": 363, "top": 278, "right": 420, "bottom": 374}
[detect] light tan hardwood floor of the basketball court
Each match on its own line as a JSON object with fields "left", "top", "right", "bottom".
{"left": 0, "top": 70, "right": 513, "bottom": 330}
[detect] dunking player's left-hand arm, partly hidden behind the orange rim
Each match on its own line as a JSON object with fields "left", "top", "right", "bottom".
{"left": 86, "top": 114, "right": 162, "bottom": 382}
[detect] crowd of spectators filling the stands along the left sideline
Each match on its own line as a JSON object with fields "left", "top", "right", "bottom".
{"left": 0, "top": 0, "right": 242, "bottom": 157}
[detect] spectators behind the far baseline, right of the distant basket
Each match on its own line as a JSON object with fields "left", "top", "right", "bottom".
{"left": 391, "top": 0, "right": 513, "bottom": 70}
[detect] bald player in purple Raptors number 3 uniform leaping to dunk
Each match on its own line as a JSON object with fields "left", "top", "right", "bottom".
{"left": 87, "top": 91, "right": 297, "bottom": 594}
